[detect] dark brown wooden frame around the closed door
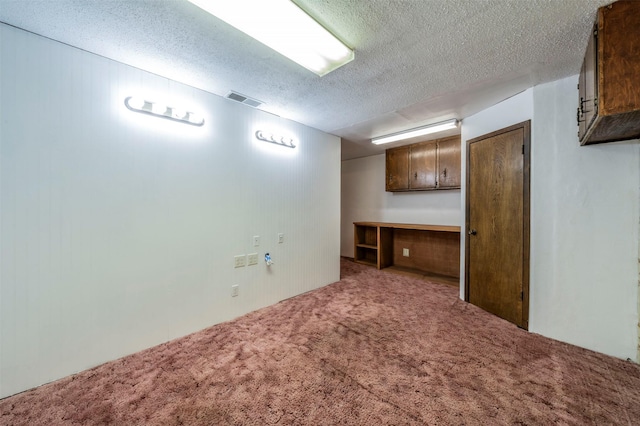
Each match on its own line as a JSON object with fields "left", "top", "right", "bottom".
{"left": 464, "top": 120, "right": 531, "bottom": 330}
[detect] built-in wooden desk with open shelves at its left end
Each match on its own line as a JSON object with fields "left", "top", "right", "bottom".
{"left": 353, "top": 222, "right": 460, "bottom": 278}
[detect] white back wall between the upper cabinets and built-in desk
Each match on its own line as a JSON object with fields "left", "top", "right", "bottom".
{"left": 340, "top": 154, "right": 460, "bottom": 257}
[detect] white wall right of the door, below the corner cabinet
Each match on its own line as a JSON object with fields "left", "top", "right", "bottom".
{"left": 530, "top": 77, "right": 640, "bottom": 359}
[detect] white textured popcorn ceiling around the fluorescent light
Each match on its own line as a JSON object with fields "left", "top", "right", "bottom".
{"left": 0, "top": 0, "right": 610, "bottom": 159}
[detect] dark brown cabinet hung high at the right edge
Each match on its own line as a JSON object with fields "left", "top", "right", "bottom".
{"left": 577, "top": 0, "right": 640, "bottom": 145}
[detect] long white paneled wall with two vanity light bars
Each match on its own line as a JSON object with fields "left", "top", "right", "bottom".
{"left": 0, "top": 24, "right": 340, "bottom": 397}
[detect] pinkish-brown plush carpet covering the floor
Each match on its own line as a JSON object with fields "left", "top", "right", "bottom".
{"left": 0, "top": 260, "right": 640, "bottom": 425}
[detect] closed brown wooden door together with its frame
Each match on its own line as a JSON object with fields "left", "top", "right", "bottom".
{"left": 465, "top": 121, "right": 531, "bottom": 329}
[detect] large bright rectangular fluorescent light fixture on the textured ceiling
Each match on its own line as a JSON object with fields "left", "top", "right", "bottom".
{"left": 189, "top": 0, "right": 354, "bottom": 77}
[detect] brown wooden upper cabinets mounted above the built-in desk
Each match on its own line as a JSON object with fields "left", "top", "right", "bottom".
{"left": 386, "top": 136, "right": 461, "bottom": 192}
